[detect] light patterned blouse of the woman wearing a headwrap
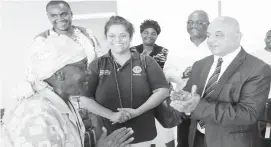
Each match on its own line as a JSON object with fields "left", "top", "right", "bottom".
{"left": 3, "top": 88, "right": 85, "bottom": 147}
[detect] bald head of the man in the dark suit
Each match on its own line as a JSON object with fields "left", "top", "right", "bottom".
{"left": 207, "top": 16, "right": 242, "bottom": 56}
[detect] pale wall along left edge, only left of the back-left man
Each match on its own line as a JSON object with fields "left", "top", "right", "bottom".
{"left": 0, "top": 2, "right": 50, "bottom": 107}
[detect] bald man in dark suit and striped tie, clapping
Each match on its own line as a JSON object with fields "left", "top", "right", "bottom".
{"left": 174, "top": 17, "right": 271, "bottom": 147}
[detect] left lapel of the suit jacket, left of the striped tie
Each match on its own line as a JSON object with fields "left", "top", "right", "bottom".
{"left": 198, "top": 56, "right": 214, "bottom": 95}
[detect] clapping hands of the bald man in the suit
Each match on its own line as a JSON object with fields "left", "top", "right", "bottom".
{"left": 170, "top": 85, "right": 200, "bottom": 113}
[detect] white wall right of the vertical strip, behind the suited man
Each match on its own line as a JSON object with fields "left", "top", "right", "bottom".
{"left": 222, "top": 0, "right": 271, "bottom": 53}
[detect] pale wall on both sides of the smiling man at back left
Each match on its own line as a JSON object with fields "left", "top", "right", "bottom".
{"left": 0, "top": 0, "right": 117, "bottom": 108}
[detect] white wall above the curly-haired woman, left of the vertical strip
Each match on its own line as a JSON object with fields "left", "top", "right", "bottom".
{"left": 118, "top": 0, "right": 218, "bottom": 52}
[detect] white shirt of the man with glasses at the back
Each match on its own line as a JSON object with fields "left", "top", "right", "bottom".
{"left": 164, "top": 36, "right": 211, "bottom": 89}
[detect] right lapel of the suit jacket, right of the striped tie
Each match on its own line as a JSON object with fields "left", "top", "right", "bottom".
{"left": 210, "top": 48, "right": 247, "bottom": 100}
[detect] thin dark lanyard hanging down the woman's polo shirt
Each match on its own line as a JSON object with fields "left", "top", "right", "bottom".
{"left": 113, "top": 59, "right": 133, "bottom": 108}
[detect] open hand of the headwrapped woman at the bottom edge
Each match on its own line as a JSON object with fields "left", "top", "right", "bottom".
{"left": 95, "top": 127, "right": 134, "bottom": 147}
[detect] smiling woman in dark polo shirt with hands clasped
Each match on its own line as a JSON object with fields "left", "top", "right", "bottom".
{"left": 81, "top": 16, "right": 169, "bottom": 147}
